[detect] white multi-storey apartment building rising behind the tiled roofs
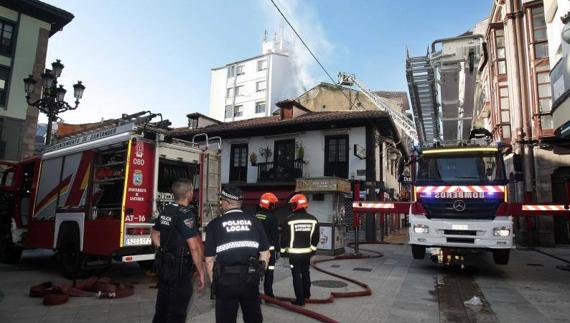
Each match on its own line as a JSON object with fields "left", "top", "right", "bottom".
{"left": 209, "top": 33, "right": 300, "bottom": 122}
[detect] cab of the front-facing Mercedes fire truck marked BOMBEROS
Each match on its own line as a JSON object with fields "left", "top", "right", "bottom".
{"left": 409, "top": 146, "right": 513, "bottom": 265}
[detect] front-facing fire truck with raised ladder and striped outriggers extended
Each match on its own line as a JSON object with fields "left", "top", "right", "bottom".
{"left": 339, "top": 35, "right": 570, "bottom": 266}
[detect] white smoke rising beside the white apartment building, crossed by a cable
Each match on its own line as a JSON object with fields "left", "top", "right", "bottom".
{"left": 258, "top": 0, "right": 334, "bottom": 93}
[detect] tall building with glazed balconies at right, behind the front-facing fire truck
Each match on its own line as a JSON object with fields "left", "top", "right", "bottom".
{"left": 474, "top": 0, "right": 570, "bottom": 245}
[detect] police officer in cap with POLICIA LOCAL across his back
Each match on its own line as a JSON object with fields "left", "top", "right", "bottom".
{"left": 205, "top": 186, "right": 270, "bottom": 323}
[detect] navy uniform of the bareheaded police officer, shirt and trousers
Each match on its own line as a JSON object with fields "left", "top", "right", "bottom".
{"left": 153, "top": 204, "right": 198, "bottom": 323}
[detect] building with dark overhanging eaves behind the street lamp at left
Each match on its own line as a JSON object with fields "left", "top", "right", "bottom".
{"left": 0, "top": 0, "right": 73, "bottom": 161}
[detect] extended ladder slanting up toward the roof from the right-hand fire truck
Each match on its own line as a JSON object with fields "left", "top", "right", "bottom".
{"left": 338, "top": 72, "right": 418, "bottom": 141}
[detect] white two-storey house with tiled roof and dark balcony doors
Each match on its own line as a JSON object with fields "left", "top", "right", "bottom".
{"left": 172, "top": 100, "right": 407, "bottom": 239}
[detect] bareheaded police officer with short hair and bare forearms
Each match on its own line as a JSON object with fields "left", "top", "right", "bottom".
{"left": 151, "top": 179, "right": 204, "bottom": 323}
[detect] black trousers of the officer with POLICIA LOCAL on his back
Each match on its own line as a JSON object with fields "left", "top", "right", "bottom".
{"left": 216, "top": 269, "right": 263, "bottom": 323}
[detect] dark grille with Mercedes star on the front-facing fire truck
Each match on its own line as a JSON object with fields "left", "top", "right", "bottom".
{"left": 420, "top": 198, "right": 501, "bottom": 220}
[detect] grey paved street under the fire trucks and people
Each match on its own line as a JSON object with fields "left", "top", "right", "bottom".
{"left": 0, "top": 245, "right": 570, "bottom": 323}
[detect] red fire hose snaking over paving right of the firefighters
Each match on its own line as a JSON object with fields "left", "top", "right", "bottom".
{"left": 261, "top": 242, "right": 383, "bottom": 323}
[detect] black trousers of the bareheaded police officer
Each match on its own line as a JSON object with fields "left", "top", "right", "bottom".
{"left": 152, "top": 265, "right": 192, "bottom": 323}
